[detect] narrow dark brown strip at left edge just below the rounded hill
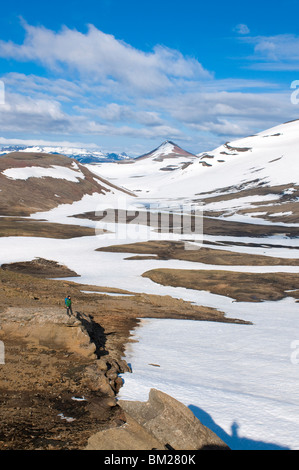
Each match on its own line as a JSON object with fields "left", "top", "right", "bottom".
{"left": 0, "top": 217, "right": 95, "bottom": 239}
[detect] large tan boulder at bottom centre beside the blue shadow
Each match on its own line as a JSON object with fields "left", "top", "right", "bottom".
{"left": 87, "top": 389, "right": 229, "bottom": 450}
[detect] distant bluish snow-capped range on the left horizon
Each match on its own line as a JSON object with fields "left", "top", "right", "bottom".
{"left": 0, "top": 145, "right": 130, "bottom": 164}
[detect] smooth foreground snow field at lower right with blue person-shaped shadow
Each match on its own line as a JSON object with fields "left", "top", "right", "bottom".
{"left": 119, "top": 299, "right": 299, "bottom": 450}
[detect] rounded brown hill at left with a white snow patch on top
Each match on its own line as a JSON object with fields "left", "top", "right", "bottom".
{"left": 0, "top": 152, "right": 132, "bottom": 216}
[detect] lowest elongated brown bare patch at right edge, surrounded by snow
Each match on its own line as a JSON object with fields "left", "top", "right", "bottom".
{"left": 143, "top": 269, "right": 299, "bottom": 302}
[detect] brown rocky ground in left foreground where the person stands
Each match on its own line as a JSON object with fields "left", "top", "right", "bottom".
{"left": 0, "top": 259, "right": 237, "bottom": 450}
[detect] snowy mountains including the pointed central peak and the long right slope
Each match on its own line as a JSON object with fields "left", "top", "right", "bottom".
{"left": 86, "top": 120, "right": 299, "bottom": 223}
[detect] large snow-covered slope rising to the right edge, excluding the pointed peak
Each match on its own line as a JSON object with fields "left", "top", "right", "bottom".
{"left": 148, "top": 120, "right": 299, "bottom": 223}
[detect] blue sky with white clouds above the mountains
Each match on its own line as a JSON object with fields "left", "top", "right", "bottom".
{"left": 0, "top": 0, "right": 299, "bottom": 156}
